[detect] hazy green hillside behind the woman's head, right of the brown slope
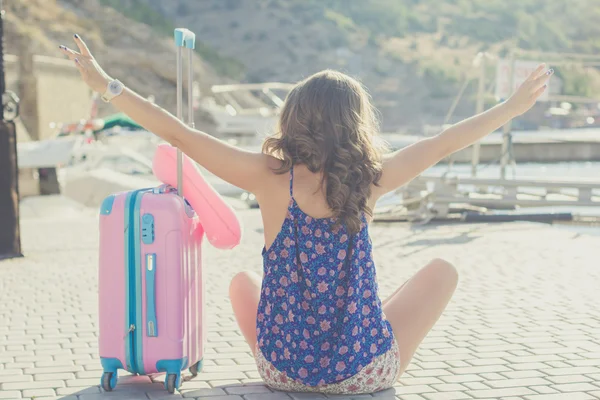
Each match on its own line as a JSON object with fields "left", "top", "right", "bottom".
{"left": 142, "top": 0, "right": 600, "bottom": 129}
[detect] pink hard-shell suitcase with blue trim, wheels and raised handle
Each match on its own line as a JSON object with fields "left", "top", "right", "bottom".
{"left": 99, "top": 29, "right": 217, "bottom": 393}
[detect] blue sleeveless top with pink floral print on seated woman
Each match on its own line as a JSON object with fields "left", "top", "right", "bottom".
{"left": 256, "top": 169, "right": 394, "bottom": 387}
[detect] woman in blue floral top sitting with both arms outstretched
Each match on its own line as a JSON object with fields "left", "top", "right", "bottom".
{"left": 61, "top": 35, "right": 552, "bottom": 394}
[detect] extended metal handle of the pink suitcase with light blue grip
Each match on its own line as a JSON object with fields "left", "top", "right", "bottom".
{"left": 174, "top": 28, "right": 196, "bottom": 197}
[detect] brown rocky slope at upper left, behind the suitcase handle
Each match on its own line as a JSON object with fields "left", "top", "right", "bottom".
{"left": 4, "top": 0, "right": 231, "bottom": 126}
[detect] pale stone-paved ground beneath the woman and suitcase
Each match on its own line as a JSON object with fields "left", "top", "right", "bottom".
{"left": 0, "top": 198, "right": 600, "bottom": 400}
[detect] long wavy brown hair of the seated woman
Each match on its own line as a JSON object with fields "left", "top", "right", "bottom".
{"left": 262, "top": 70, "right": 385, "bottom": 233}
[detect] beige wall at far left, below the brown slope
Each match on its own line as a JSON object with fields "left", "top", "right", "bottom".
{"left": 4, "top": 54, "right": 91, "bottom": 141}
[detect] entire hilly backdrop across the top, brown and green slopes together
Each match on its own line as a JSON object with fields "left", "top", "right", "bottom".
{"left": 5, "top": 0, "right": 600, "bottom": 131}
